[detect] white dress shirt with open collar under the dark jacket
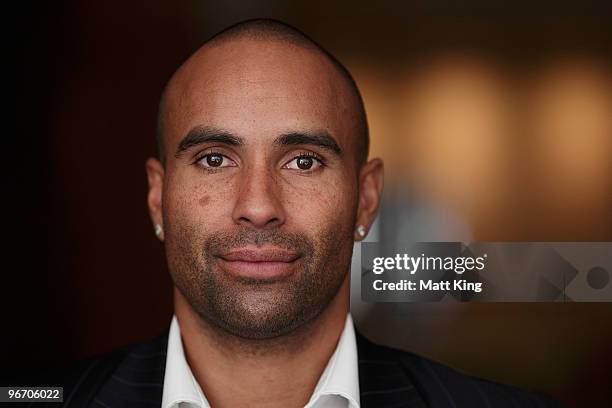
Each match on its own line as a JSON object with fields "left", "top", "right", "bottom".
{"left": 162, "top": 314, "right": 359, "bottom": 408}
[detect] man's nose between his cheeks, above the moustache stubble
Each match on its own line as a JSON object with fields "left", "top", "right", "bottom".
{"left": 232, "top": 166, "right": 285, "bottom": 228}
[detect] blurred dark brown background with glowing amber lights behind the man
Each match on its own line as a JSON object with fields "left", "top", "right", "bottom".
{"left": 0, "top": 0, "right": 612, "bottom": 406}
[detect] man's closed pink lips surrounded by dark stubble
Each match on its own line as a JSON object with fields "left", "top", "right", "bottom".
{"left": 218, "top": 247, "right": 300, "bottom": 280}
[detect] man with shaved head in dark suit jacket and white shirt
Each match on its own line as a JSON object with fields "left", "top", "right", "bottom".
{"left": 58, "top": 20, "right": 564, "bottom": 408}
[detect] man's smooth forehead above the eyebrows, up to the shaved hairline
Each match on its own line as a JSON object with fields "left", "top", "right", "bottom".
{"left": 163, "top": 39, "right": 356, "bottom": 151}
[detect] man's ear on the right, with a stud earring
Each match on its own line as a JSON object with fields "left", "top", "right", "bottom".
{"left": 355, "top": 159, "right": 384, "bottom": 241}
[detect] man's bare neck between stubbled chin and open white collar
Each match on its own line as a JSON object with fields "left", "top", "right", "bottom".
{"left": 174, "top": 274, "right": 349, "bottom": 408}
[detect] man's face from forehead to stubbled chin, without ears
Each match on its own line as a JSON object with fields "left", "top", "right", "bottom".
{"left": 152, "top": 39, "right": 372, "bottom": 338}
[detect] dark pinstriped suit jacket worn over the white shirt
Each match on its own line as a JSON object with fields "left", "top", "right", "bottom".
{"left": 45, "top": 330, "right": 561, "bottom": 408}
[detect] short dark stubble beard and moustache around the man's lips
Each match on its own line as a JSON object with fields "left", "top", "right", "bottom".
{"left": 166, "top": 224, "right": 352, "bottom": 340}
